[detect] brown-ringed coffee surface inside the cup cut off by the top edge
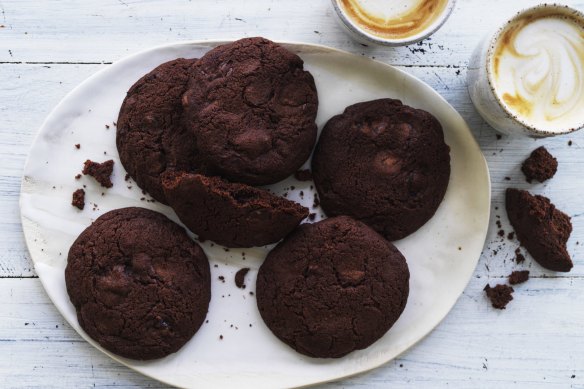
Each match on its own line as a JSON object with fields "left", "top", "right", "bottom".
{"left": 338, "top": 0, "right": 448, "bottom": 39}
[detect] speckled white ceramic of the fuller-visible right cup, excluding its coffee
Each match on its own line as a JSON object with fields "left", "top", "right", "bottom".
{"left": 467, "top": 4, "right": 584, "bottom": 137}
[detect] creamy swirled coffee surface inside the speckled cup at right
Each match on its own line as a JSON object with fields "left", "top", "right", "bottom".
{"left": 490, "top": 9, "right": 584, "bottom": 132}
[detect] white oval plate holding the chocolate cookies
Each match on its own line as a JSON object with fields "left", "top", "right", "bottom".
{"left": 20, "top": 42, "right": 490, "bottom": 388}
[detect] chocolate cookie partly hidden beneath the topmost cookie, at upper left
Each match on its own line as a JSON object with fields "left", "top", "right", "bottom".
{"left": 116, "top": 58, "right": 203, "bottom": 204}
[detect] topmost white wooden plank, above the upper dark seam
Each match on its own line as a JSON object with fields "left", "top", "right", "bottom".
{"left": 0, "top": 0, "right": 584, "bottom": 66}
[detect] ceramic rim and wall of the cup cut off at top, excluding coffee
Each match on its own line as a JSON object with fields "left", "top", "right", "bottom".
{"left": 332, "top": 0, "right": 456, "bottom": 46}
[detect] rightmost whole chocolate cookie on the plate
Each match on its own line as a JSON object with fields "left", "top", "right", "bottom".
{"left": 312, "top": 99, "right": 450, "bottom": 240}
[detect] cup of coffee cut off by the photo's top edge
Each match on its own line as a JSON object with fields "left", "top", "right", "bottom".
{"left": 332, "top": 0, "right": 455, "bottom": 46}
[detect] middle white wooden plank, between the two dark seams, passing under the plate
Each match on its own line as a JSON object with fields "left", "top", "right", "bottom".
{"left": 0, "top": 64, "right": 584, "bottom": 277}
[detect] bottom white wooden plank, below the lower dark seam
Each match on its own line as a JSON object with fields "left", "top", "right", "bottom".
{"left": 0, "top": 278, "right": 584, "bottom": 388}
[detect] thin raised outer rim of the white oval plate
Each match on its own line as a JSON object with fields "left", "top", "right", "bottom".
{"left": 18, "top": 38, "right": 492, "bottom": 388}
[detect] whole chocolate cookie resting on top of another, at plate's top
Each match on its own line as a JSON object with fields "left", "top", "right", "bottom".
{"left": 183, "top": 38, "right": 318, "bottom": 185}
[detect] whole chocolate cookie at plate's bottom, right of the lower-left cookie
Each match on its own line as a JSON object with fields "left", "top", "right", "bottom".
{"left": 256, "top": 216, "right": 410, "bottom": 358}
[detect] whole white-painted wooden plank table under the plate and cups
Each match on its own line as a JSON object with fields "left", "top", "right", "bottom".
{"left": 0, "top": 0, "right": 584, "bottom": 388}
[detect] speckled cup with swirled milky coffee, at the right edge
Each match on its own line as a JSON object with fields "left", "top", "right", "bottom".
{"left": 468, "top": 4, "right": 584, "bottom": 137}
